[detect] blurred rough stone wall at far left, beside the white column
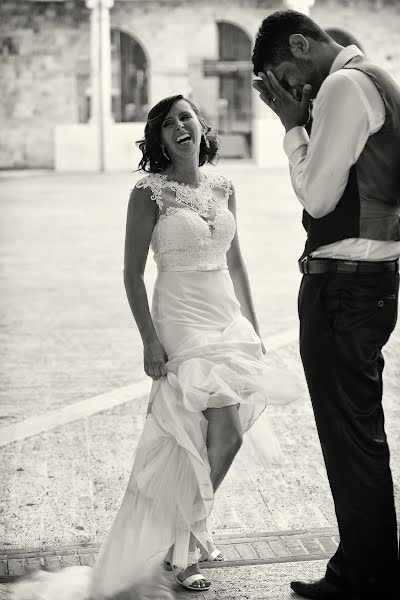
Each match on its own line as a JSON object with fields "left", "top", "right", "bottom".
{"left": 0, "top": 0, "right": 89, "bottom": 168}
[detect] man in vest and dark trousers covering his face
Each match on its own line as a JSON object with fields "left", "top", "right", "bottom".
{"left": 253, "top": 11, "right": 400, "bottom": 600}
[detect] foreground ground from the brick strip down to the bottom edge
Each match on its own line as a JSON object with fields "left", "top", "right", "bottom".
{"left": 0, "top": 529, "right": 338, "bottom": 600}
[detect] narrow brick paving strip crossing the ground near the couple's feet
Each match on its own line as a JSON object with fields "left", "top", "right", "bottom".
{"left": 0, "top": 527, "right": 338, "bottom": 582}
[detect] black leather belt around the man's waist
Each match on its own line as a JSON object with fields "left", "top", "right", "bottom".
{"left": 299, "top": 256, "right": 399, "bottom": 275}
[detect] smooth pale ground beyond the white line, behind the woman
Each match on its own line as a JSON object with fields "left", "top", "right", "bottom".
{"left": 0, "top": 167, "right": 303, "bottom": 424}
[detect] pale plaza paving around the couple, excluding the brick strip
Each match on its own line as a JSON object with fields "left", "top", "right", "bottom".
{"left": 0, "top": 163, "right": 400, "bottom": 599}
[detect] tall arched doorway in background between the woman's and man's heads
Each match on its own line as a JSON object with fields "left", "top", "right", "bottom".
{"left": 217, "top": 22, "right": 252, "bottom": 158}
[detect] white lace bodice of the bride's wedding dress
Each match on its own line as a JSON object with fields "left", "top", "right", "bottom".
{"left": 136, "top": 173, "right": 236, "bottom": 271}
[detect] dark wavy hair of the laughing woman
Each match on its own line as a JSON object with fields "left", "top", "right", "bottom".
{"left": 136, "top": 94, "right": 219, "bottom": 173}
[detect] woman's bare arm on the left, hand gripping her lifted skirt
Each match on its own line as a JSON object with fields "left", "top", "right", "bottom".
{"left": 124, "top": 188, "right": 167, "bottom": 379}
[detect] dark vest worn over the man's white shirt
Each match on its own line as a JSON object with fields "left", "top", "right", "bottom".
{"left": 303, "top": 58, "right": 400, "bottom": 257}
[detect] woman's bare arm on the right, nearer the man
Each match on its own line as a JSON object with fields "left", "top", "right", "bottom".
{"left": 227, "top": 187, "right": 261, "bottom": 350}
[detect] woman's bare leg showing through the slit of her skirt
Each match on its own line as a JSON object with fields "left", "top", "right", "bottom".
{"left": 203, "top": 405, "right": 242, "bottom": 492}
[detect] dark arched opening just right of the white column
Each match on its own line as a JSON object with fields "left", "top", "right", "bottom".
{"left": 111, "top": 29, "right": 149, "bottom": 122}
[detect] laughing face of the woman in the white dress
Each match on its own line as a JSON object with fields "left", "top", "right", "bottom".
{"left": 161, "top": 100, "right": 202, "bottom": 160}
